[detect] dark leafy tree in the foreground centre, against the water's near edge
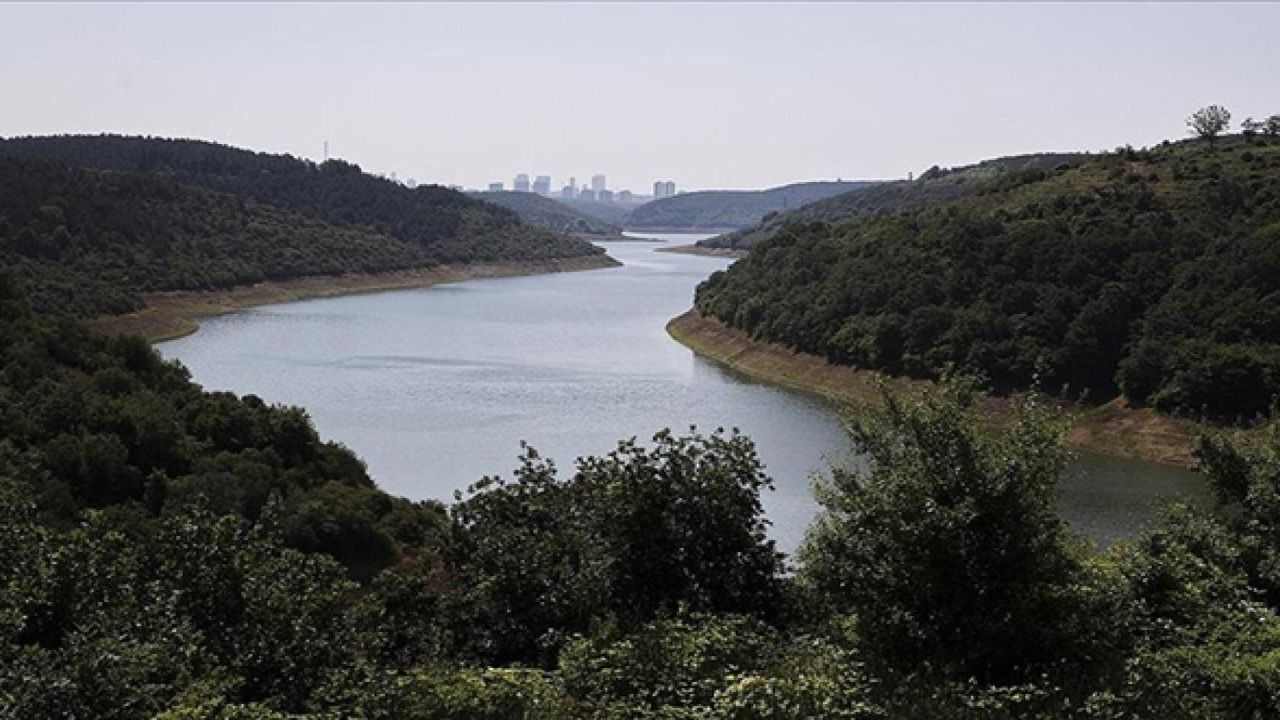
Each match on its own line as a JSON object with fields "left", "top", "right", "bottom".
{"left": 451, "top": 430, "right": 781, "bottom": 660}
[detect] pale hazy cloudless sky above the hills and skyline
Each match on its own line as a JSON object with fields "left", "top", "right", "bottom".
{"left": 0, "top": 3, "right": 1280, "bottom": 192}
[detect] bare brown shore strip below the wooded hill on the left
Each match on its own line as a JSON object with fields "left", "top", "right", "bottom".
{"left": 88, "top": 254, "right": 621, "bottom": 343}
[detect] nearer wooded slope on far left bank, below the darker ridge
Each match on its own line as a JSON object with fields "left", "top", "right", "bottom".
{"left": 0, "top": 156, "right": 436, "bottom": 315}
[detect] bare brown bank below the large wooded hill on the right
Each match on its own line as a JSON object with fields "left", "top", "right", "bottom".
{"left": 667, "top": 310, "right": 1202, "bottom": 469}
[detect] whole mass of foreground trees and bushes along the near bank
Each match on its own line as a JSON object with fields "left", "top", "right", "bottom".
{"left": 0, "top": 263, "right": 1280, "bottom": 720}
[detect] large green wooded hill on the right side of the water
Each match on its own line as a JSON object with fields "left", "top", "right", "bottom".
{"left": 696, "top": 138, "right": 1280, "bottom": 418}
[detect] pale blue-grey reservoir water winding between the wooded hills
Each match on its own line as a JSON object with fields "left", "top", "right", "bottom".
{"left": 157, "top": 236, "right": 1206, "bottom": 551}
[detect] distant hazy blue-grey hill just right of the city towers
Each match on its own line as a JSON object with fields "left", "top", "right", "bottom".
{"left": 626, "top": 182, "right": 873, "bottom": 229}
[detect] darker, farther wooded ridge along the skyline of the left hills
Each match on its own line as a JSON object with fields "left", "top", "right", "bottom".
{"left": 0, "top": 135, "right": 599, "bottom": 263}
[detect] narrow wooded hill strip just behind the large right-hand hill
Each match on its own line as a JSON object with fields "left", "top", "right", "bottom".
{"left": 698, "top": 152, "right": 1087, "bottom": 250}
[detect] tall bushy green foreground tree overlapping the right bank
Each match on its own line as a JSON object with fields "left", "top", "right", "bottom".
{"left": 800, "top": 382, "right": 1121, "bottom": 685}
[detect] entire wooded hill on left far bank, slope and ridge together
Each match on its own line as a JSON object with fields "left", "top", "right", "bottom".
{"left": 0, "top": 136, "right": 600, "bottom": 314}
